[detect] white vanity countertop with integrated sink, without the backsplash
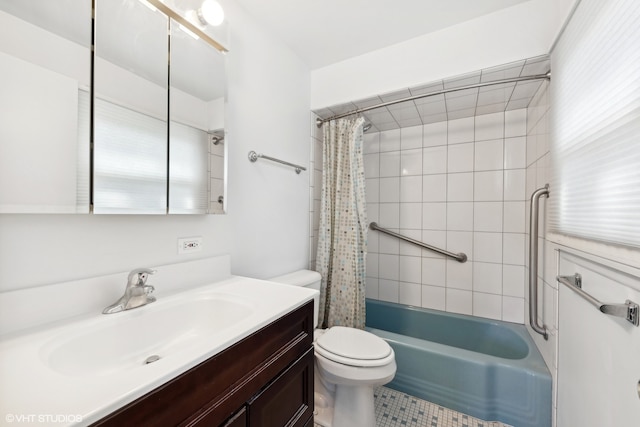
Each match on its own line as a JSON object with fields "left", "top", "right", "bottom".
{"left": 0, "top": 276, "right": 317, "bottom": 427}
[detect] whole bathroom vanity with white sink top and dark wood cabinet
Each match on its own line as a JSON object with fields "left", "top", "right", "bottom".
{"left": 0, "top": 257, "right": 318, "bottom": 427}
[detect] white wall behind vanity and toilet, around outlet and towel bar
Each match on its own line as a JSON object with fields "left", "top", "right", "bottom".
{"left": 0, "top": 2, "right": 309, "bottom": 291}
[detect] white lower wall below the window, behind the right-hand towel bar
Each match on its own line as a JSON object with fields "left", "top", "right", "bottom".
{"left": 557, "top": 249, "right": 640, "bottom": 427}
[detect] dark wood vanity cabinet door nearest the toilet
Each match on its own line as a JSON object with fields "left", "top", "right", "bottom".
{"left": 248, "top": 349, "right": 314, "bottom": 427}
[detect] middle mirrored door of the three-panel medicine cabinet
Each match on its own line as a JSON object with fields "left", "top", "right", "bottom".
{"left": 93, "top": 0, "right": 169, "bottom": 214}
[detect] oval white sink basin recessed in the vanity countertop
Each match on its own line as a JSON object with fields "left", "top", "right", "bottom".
{"left": 41, "top": 295, "right": 253, "bottom": 376}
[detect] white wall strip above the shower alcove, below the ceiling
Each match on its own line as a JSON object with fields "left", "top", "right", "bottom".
{"left": 311, "top": 0, "right": 576, "bottom": 110}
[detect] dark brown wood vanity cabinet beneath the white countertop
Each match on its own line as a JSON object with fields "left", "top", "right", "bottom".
{"left": 93, "top": 301, "right": 314, "bottom": 427}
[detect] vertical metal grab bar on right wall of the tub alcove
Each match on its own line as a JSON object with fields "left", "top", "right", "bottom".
{"left": 529, "top": 184, "right": 549, "bottom": 340}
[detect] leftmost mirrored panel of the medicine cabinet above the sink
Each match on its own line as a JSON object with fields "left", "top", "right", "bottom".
{"left": 0, "top": 0, "right": 91, "bottom": 213}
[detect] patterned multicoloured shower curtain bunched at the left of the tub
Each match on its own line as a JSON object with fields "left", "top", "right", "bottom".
{"left": 316, "top": 117, "right": 368, "bottom": 329}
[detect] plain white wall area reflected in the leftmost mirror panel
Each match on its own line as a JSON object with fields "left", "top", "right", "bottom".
{"left": 0, "top": 52, "right": 79, "bottom": 213}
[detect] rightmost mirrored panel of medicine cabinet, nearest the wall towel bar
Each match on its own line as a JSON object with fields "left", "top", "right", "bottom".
{"left": 169, "top": 20, "right": 226, "bottom": 214}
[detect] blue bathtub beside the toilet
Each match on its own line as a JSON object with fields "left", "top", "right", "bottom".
{"left": 366, "top": 300, "right": 551, "bottom": 427}
